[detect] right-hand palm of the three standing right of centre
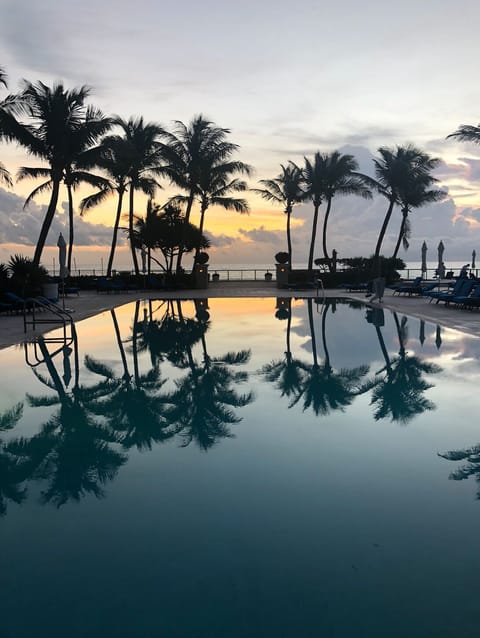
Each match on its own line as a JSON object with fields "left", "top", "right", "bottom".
{"left": 322, "top": 151, "right": 372, "bottom": 263}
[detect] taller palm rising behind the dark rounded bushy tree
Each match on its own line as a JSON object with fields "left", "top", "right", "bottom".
{"left": 163, "top": 115, "right": 238, "bottom": 273}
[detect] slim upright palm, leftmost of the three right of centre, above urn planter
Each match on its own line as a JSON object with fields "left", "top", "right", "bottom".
{"left": 251, "top": 161, "right": 304, "bottom": 265}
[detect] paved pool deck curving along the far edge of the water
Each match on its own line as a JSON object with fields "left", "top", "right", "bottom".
{"left": 0, "top": 281, "right": 480, "bottom": 348}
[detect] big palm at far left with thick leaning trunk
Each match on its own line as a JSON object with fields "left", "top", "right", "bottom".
{"left": 0, "top": 82, "right": 110, "bottom": 265}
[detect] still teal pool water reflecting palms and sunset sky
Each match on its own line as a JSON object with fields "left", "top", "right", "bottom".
{"left": 0, "top": 299, "right": 480, "bottom": 638}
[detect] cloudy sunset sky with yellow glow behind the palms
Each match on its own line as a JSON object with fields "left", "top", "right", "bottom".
{"left": 0, "top": 0, "right": 480, "bottom": 267}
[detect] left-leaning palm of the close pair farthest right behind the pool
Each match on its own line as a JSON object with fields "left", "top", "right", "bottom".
{"left": 370, "top": 144, "right": 440, "bottom": 269}
